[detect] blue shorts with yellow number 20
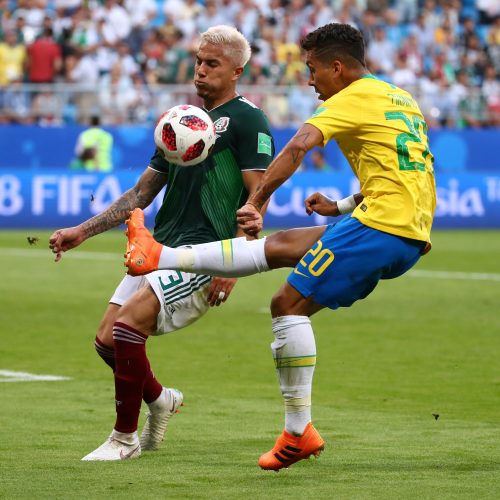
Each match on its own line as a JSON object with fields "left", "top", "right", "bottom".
{"left": 288, "top": 217, "right": 425, "bottom": 309}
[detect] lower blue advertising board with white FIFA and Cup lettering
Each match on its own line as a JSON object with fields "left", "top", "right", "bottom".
{"left": 0, "top": 169, "right": 500, "bottom": 229}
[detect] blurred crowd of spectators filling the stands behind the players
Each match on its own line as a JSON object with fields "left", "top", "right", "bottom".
{"left": 0, "top": 0, "right": 500, "bottom": 127}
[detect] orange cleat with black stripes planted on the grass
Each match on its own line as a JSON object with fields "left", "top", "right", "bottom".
{"left": 259, "top": 422, "right": 325, "bottom": 472}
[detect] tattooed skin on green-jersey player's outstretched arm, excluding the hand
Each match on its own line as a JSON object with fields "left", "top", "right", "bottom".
{"left": 82, "top": 171, "right": 166, "bottom": 238}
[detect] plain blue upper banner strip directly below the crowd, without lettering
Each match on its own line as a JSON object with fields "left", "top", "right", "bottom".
{"left": 0, "top": 125, "right": 500, "bottom": 174}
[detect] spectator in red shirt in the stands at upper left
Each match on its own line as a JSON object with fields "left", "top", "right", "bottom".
{"left": 27, "top": 28, "right": 62, "bottom": 83}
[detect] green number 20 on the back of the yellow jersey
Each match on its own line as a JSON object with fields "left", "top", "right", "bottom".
{"left": 385, "top": 111, "right": 430, "bottom": 172}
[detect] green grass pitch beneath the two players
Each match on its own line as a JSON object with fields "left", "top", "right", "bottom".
{"left": 0, "top": 231, "right": 500, "bottom": 500}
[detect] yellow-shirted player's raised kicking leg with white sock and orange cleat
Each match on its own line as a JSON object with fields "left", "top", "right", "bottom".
{"left": 126, "top": 207, "right": 326, "bottom": 277}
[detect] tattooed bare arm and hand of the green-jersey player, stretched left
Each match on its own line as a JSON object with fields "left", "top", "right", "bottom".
{"left": 49, "top": 168, "right": 167, "bottom": 262}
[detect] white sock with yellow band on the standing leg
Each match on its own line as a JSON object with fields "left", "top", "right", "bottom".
{"left": 271, "top": 316, "right": 316, "bottom": 435}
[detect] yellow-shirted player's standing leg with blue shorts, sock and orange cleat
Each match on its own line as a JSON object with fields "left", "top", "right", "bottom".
{"left": 259, "top": 218, "right": 424, "bottom": 470}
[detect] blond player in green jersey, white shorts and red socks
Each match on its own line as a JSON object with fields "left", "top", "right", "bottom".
{"left": 49, "top": 26, "right": 274, "bottom": 461}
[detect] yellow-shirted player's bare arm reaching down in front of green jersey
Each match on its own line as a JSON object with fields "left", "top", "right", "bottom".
{"left": 237, "top": 123, "right": 323, "bottom": 236}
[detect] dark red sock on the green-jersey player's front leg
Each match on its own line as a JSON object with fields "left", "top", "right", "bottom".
{"left": 113, "top": 321, "right": 151, "bottom": 432}
